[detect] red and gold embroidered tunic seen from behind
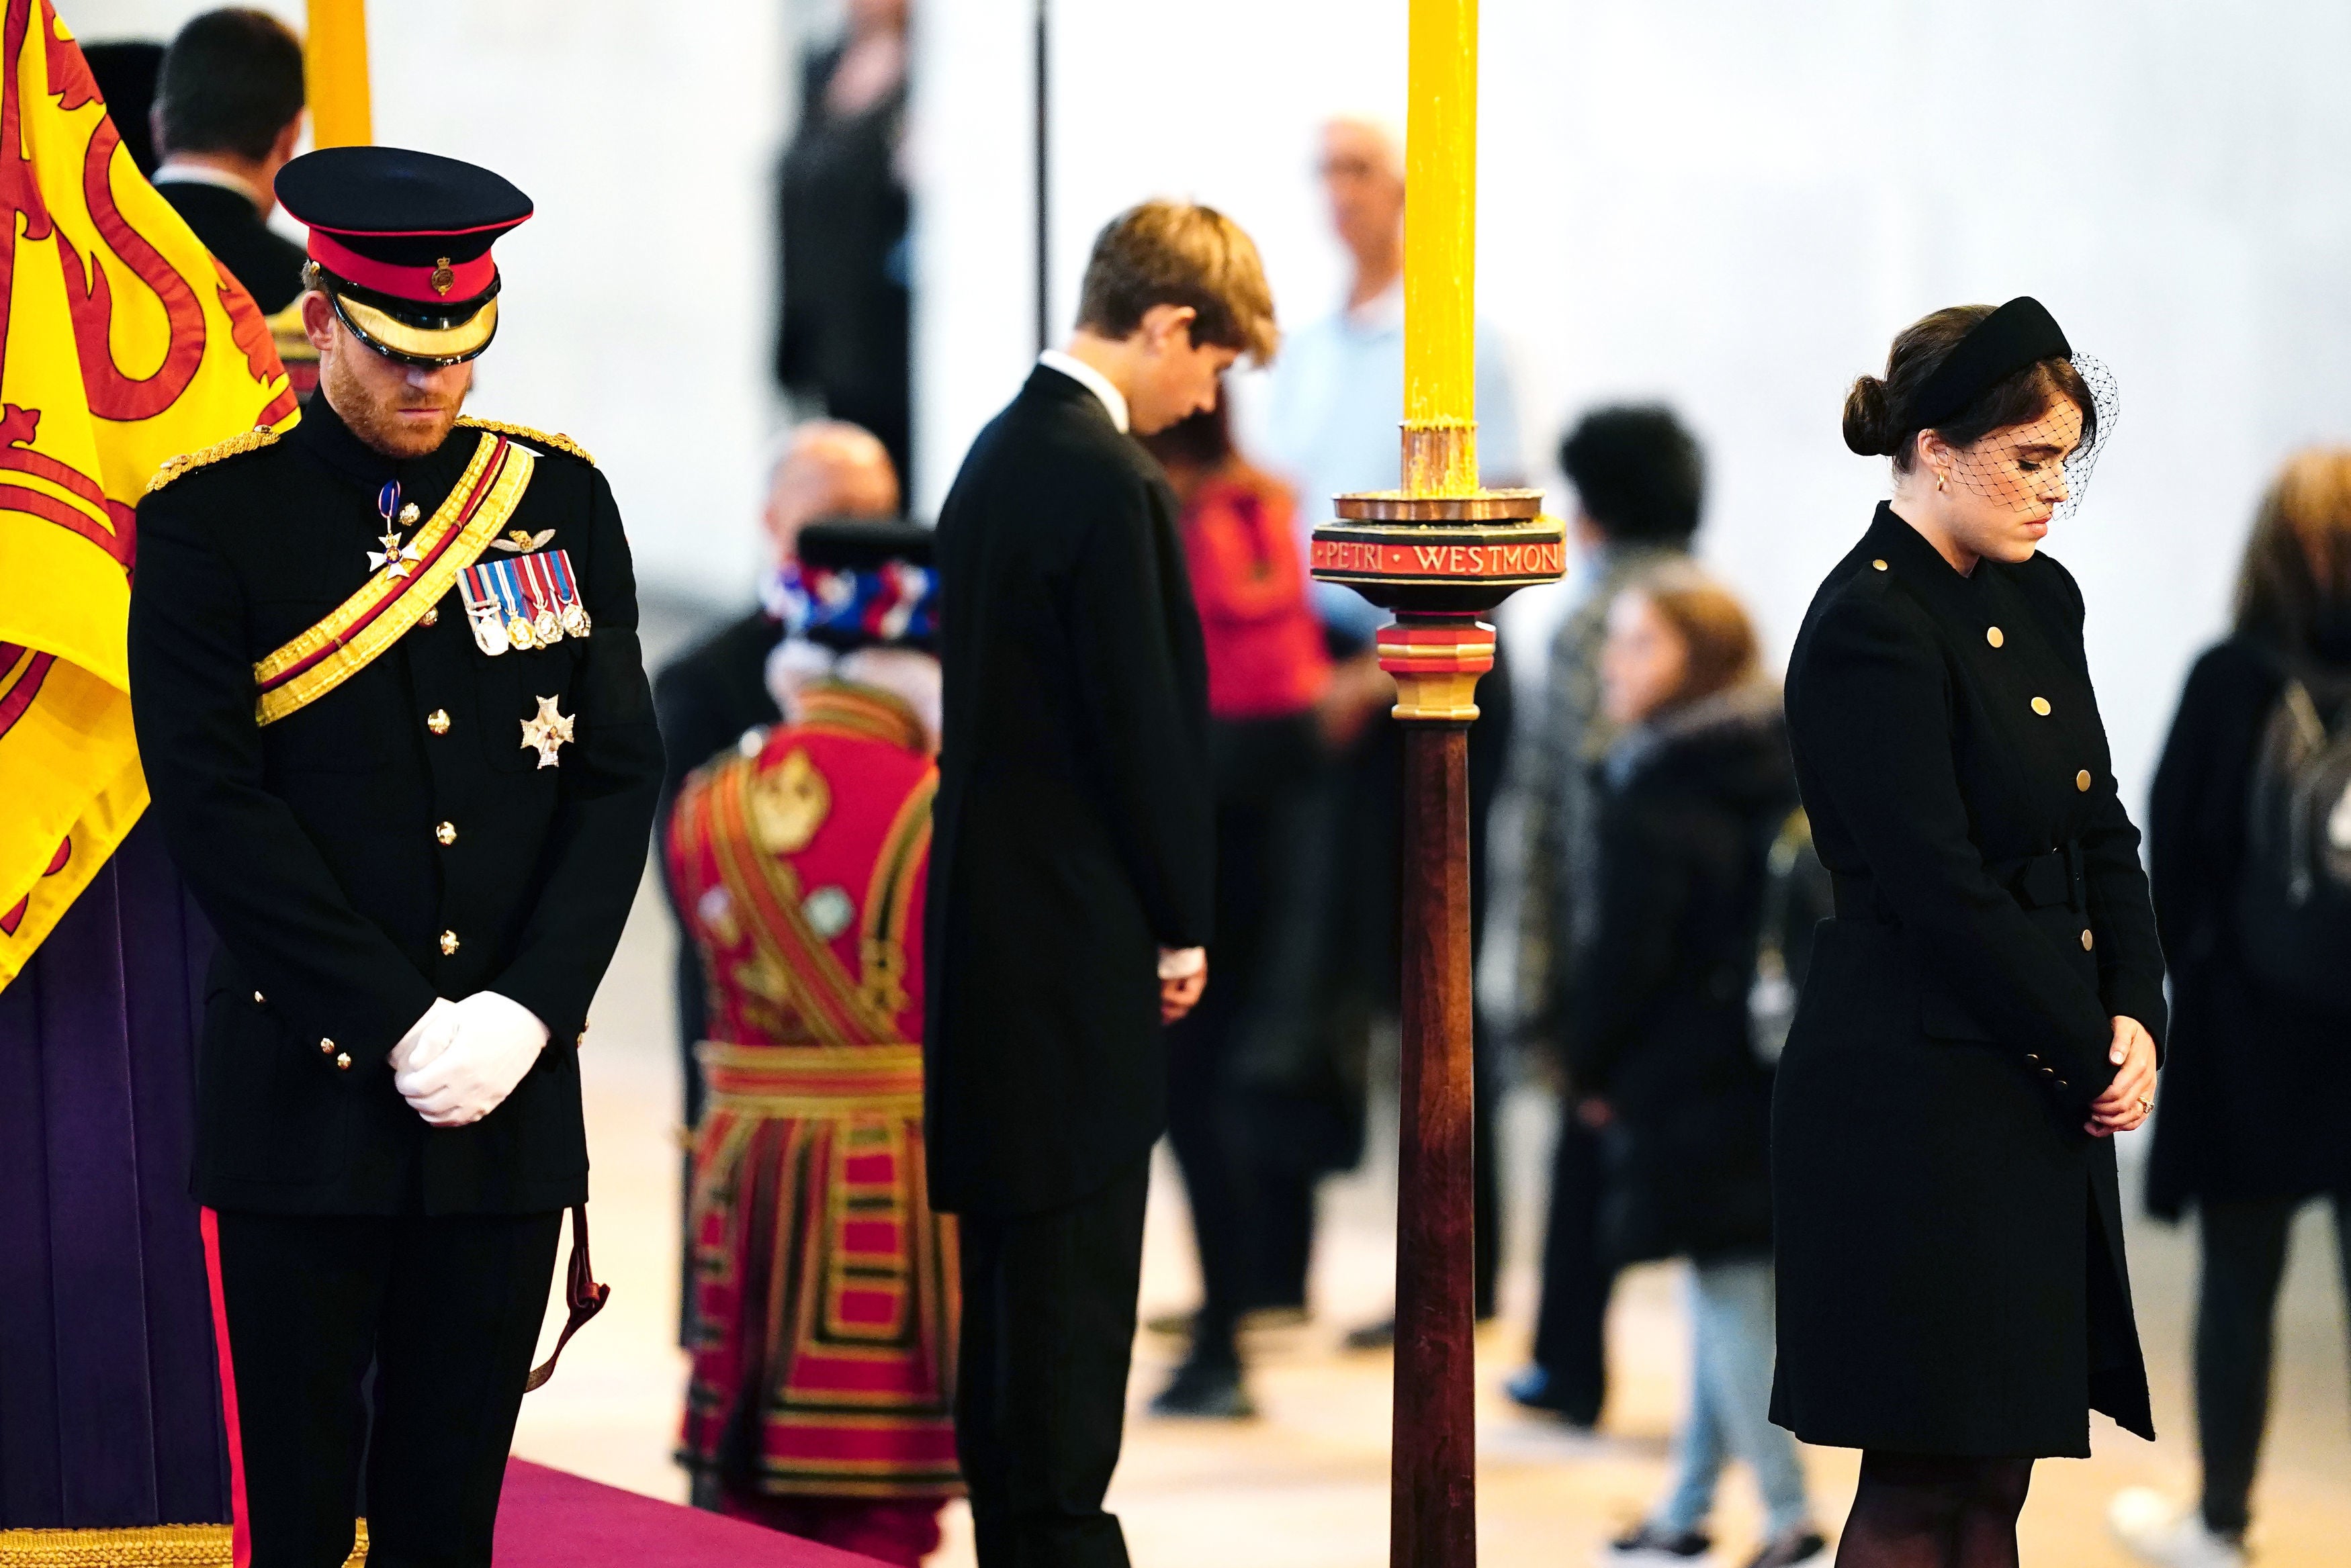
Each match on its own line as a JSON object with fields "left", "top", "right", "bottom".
{"left": 668, "top": 684, "right": 962, "bottom": 1497}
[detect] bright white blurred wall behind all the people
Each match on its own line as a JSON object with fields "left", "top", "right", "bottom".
{"left": 61, "top": 0, "right": 2351, "bottom": 788}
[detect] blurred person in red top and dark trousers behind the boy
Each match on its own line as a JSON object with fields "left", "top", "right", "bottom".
{"left": 1143, "top": 395, "right": 1331, "bottom": 1418}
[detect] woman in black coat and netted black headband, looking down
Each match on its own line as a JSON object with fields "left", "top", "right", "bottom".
{"left": 1771, "top": 299, "right": 2166, "bottom": 1568}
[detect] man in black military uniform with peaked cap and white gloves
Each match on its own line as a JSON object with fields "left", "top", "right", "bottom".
{"left": 130, "top": 148, "right": 661, "bottom": 1568}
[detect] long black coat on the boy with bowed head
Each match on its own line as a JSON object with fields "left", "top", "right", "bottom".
{"left": 924, "top": 367, "right": 1216, "bottom": 1215}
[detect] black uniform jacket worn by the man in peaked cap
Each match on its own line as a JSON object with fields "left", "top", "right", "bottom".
{"left": 130, "top": 398, "right": 661, "bottom": 1213}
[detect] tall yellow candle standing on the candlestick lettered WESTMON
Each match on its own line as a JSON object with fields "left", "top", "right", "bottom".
{"left": 1404, "top": 0, "right": 1479, "bottom": 496}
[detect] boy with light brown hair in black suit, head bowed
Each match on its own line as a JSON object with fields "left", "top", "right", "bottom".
{"left": 924, "top": 202, "right": 1277, "bottom": 1568}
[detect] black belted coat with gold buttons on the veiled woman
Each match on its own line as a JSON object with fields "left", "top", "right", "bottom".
{"left": 1773, "top": 506, "right": 2166, "bottom": 1455}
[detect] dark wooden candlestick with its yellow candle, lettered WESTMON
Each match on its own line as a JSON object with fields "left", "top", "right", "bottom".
{"left": 1315, "top": 0, "right": 1566, "bottom": 1568}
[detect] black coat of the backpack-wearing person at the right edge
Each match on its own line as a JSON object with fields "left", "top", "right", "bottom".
{"left": 2147, "top": 637, "right": 2351, "bottom": 1217}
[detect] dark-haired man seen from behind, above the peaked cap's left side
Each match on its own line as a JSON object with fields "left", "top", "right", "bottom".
{"left": 148, "top": 9, "right": 306, "bottom": 315}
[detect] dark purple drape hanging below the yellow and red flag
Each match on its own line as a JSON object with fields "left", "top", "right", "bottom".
{"left": 0, "top": 823, "right": 228, "bottom": 1528}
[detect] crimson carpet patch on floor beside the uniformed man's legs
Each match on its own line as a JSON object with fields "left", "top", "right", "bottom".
{"left": 498, "top": 1460, "right": 875, "bottom": 1568}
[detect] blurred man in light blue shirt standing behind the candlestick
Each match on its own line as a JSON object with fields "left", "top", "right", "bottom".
{"left": 1253, "top": 116, "right": 1523, "bottom": 1347}
